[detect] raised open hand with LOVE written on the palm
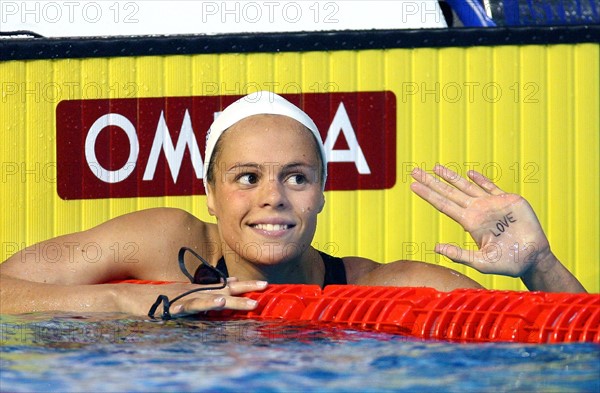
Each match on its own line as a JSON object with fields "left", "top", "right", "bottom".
{"left": 411, "top": 165, "right": 550, "bottom": 277}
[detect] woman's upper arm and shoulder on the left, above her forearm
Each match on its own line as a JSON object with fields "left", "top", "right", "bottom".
{"left": 0, "top": 208, "right": 206, "bottom": 286}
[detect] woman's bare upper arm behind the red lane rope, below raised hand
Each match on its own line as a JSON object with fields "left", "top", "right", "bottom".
{"left": 344, "top": 257, "right": 482, "bottom": 291}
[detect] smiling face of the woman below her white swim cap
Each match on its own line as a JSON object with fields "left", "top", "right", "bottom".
{"left": 208, "top": 115, "right": 324, "bottom": 264}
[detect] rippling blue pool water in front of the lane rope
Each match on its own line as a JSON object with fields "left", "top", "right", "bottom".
{"left": 0, "top": 314, "right": 600, "bottom": 392}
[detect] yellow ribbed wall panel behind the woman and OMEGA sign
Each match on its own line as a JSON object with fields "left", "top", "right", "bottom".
{"left": 0, "top": 44, "right": 600, "bottom": 292}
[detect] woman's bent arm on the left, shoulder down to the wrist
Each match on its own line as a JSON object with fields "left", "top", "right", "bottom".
{"left": 0, "top": 209, "right": 244, "bottom": 314}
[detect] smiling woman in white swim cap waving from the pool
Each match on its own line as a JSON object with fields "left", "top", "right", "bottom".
{"left": 0, "top": 92, "right": 584, "bottom": 315}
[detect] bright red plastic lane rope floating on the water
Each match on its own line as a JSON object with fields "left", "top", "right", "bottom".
{"left": 115, "top": 280, "right": 600, "bottom": 343}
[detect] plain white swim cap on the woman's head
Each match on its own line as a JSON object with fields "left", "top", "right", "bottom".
{"left": 204, "top": 91, "right": 327, "bottom": 194}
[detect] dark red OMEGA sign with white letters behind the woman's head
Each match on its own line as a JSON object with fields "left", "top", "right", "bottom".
{"left": 56, "top": 91, "right": 396, "bottom": 199}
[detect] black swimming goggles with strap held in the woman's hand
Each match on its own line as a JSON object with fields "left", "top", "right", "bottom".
{"left": 148, "top": 247, "right": 227, "bottom": 321}
